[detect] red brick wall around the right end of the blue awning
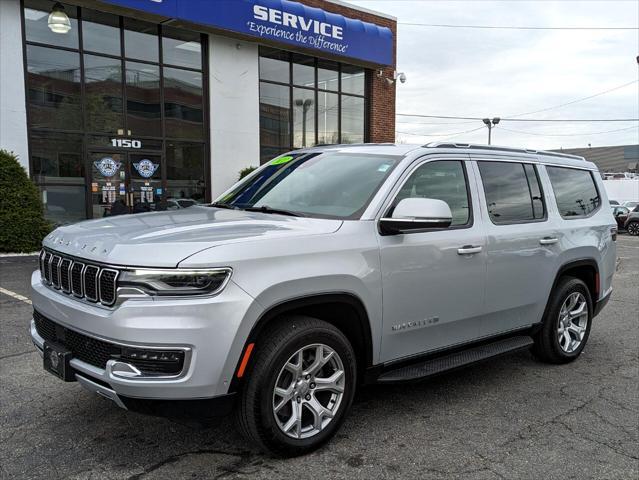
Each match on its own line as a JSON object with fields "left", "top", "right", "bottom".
{"left": 300, "top": 0, "right": 397, "bottom": 142}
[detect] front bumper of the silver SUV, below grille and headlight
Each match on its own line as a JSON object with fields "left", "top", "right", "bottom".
{"left": 30, "top": 273, "right": 253, "bottom": 415}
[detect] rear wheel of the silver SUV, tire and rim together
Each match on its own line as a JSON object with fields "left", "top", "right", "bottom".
{"left": 533, "top": 277, "right": 592, "bottom": 363}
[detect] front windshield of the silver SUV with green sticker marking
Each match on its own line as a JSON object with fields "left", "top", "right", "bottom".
{"left": 214, "top": 152, "right": 402, "bottom": 219}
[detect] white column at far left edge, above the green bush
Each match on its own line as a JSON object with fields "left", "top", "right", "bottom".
{"left": 0, "top": 0, "right": 29, "bottom": 172}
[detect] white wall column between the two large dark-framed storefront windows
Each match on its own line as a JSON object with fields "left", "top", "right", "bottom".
{"left": 209, "top": 35, "right": 260, "bottom": 199}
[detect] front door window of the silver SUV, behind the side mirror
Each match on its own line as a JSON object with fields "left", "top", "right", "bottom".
{"left": 393, "top": 160, "right": 470, "bottom": 225}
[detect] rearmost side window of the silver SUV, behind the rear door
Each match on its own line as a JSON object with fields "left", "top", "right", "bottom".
{"left": 546, "top": 166, "right": 601, "bottom": 218}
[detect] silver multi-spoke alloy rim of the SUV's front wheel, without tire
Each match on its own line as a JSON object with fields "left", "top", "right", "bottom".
{"left": 273, "top": 343, "right": 346, "bottom": 439}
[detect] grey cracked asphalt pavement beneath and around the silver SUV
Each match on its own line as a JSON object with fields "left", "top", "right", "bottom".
{"left": 0, "top": 235, "right": 639, "bottom": 480}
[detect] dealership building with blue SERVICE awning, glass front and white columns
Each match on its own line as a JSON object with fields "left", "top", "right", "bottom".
{"left": 0, "top": 0, "right": 396, "bottom": 223}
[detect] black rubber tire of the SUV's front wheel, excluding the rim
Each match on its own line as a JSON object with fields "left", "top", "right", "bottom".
{"left": 237, "top": 316, "right": 357, "bottom": 457}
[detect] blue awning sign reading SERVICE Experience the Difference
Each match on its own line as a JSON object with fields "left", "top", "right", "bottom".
{"left": 102, "top": 0, "right": 393, "bottom": 65}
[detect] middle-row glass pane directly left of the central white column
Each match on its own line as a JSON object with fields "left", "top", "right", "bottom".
{"left": 164, "top": 67, "right": 204, "bottom": 140}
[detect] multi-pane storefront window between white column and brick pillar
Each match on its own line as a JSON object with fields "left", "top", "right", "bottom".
{"left": 260, "top": 47, "right": 367, "bottom": 156}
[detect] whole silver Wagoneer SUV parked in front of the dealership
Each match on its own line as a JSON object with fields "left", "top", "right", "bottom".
{"left": 31, "top": 144, "right": 617, "bottom": 455}
